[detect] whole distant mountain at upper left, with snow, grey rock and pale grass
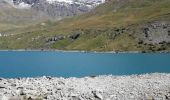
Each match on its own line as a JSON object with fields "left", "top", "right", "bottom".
{"left": 0, "top": 0, "right": 102, "bottom": 34}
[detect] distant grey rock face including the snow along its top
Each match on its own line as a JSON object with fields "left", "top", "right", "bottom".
{"left": 10, "top": 0, "right": 104, "bottom": 19}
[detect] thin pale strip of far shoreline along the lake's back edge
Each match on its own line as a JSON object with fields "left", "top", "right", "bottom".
{"left": 0, "top": 49, "right": 170, "bottom": 54}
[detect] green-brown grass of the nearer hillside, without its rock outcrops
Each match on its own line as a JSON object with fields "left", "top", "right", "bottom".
{"left": 0, "top": 0, "right": 170, "bottom": 51}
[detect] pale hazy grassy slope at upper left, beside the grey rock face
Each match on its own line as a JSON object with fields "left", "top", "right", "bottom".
{"left": 0, "top": 0, "right": 48, "bottom": 34}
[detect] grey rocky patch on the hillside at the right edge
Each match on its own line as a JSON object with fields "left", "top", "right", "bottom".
{"left": 141, "top": 21, "right": 170, "bottom": 44}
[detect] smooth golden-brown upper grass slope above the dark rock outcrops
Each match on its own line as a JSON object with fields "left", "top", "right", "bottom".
{"left": 54, "top": 0, "right": 170, "bottom": 29}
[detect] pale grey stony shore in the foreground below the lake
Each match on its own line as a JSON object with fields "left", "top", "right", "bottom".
{"left": 0, "top": 73, "right": 170, "bottom": 100}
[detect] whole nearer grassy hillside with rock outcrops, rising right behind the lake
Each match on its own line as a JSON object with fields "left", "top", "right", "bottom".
{"left": 0, "top": 0, "right": 170, "bottom": 52}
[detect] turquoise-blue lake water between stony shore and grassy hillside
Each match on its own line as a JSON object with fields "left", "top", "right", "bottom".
{"left": 0, "top": 51, "right": 170, "bottom": 78}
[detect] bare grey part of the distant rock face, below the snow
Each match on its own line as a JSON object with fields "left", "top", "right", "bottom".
{"left": 32, "top": 0, "right": 90, "bottom": 18}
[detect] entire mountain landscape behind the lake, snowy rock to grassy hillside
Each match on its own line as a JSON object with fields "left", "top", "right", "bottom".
{"left": 0, "top": 0, "right": 170, "bottom": 52}
